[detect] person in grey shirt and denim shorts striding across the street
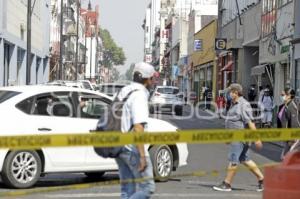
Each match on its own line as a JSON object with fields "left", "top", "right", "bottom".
{"left": 213, "top": 84, "right": 264, "bottom": 191}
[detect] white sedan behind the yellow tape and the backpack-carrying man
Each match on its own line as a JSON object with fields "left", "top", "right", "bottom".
{"left": 0, "top": 86, "right": 188, "bottom": 188}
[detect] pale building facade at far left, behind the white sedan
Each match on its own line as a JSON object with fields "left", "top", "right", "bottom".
{"left": 0, "top": 0, "right": 50, "bottom": 86}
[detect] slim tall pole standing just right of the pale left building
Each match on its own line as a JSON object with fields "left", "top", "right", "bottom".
{"left": 58, "top": 0, "right": 64, "bottom": 80}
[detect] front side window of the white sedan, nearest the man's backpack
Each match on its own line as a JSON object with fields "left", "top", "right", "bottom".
{"left": 78, "top": 95, "right": 108, "bottom": 119}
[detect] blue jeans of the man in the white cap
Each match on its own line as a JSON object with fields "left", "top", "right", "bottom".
{"left": 116, "top": 147, "right": 155, "bottom": 199}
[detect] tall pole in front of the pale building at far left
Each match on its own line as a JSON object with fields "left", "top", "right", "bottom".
{"left": 26, "top": 0, "right": 31, "bottom": 85}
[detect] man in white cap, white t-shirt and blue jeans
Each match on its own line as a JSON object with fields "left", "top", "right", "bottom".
{"left": 116, "top": 62, "right": 155, "bottom": 199}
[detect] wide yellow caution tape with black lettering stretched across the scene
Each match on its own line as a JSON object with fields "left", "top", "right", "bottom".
{"left": 0, "top": 129, "right": 300, "bottom": 149}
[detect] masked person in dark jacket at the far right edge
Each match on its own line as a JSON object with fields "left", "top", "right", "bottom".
{"left": 277, "top": 88, "right": 300, "bottom": 159}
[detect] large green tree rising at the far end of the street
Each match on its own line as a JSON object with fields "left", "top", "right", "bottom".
{"left": 99, "top": 28, "right": 126, "bottom": 68}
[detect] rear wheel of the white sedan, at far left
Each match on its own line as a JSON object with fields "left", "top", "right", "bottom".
{"left": 2, "top": 151, "right": 42, "bottom": 188}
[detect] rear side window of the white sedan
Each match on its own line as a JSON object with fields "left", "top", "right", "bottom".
{"left": 32, "top": 92, "right": 75, "bottom": 117}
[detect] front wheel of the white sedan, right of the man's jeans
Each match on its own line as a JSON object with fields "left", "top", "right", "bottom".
{"left": 149, "top": 145, "right": 173, "bottom": 182}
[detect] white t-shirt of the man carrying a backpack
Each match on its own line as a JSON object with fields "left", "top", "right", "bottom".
{"left": 117, "top": 82, "right": 149, "bottom": 155}
